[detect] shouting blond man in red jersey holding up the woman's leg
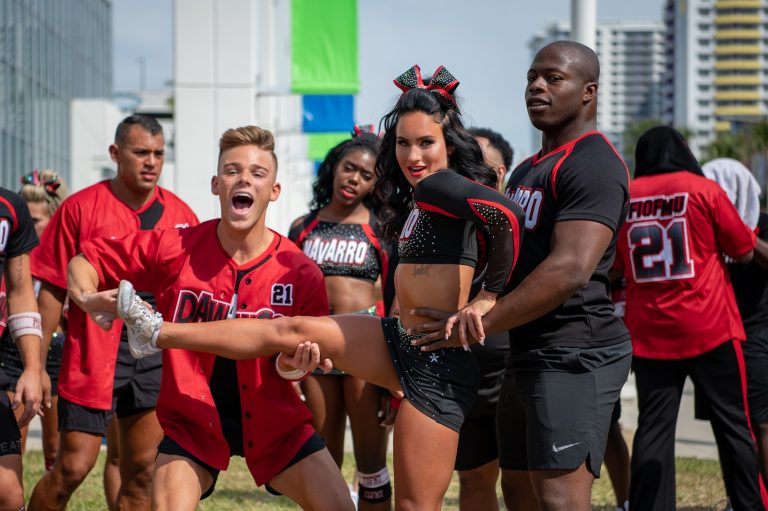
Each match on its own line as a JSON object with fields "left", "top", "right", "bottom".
{"left": 69, "top": 126, "right": 353, "bottom": 511}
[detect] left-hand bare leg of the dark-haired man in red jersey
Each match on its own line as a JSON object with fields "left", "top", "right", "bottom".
{"left": 29, "top": 430, "right": 101, "bottom": 511}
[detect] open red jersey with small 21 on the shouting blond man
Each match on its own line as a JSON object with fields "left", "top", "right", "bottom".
{"left": 83, "top": 220, "right": 328, "bottom": 484}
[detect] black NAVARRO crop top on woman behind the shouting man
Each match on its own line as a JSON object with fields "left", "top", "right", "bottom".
{"left": 288, "top": 211, "right": 388, "bottom": 282}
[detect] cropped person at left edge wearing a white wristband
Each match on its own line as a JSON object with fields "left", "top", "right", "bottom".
{"left": 0, "top": 188, "right": 45, "bottom": 510}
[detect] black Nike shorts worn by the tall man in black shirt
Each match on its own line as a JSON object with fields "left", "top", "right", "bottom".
{"left": 497, "top": 341, "right": 632, "bottom": 477}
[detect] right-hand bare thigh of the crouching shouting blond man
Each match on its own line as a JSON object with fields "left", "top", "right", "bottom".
{"left": 269, "top": 449, "right": 355, "bottom": 511}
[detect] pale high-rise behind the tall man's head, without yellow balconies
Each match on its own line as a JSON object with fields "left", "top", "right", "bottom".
{"left": 528, "top": 21, "right": 665, "bottom": 156}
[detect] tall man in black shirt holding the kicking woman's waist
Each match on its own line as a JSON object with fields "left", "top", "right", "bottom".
{"left": 416, "top": 41, "right": 632, "bottom": 511}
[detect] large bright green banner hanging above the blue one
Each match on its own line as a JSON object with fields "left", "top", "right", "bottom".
{"left": 291, "top": 0, "right": 360, "bottom": 94}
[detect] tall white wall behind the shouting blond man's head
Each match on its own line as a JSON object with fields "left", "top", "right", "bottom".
{"left": 170, "top": 0, "right": 313, "bottom": 233}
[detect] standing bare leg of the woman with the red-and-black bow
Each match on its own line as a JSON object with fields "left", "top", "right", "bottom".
{"left": 394, "top": 400, "right": 459, "bottom": 511}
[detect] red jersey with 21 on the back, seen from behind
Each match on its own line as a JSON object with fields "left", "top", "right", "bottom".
{"left": 618, "top": 171, "right": 755, "bottom": 359}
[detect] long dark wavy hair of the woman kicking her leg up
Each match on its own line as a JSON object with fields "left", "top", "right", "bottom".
{"left": 373, "top": 87, "right": 496, "bottom": 240}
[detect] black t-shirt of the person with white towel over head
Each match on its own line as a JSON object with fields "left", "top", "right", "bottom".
{"left": 728, "top": 213, "right": 768, "bottom": 334}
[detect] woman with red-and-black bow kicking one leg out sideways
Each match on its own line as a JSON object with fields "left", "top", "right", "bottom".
{"left": 109, "top": 66, "right": 523, "bottom": 510}
